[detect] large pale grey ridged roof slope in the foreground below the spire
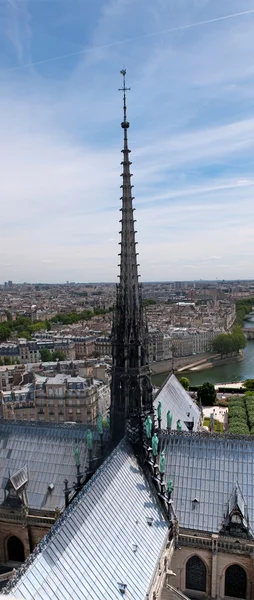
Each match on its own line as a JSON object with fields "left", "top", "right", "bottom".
{"left": 8, "top": 441, "right": 168, "bottom": 600}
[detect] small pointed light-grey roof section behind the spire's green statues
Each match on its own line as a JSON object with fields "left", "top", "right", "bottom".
{"left": 154, "top": 374, "right": 200, "bottom": 431}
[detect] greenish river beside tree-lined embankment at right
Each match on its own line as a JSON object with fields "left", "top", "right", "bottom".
{"left": 152, "top": 314, "right": 254, "bottom": 386}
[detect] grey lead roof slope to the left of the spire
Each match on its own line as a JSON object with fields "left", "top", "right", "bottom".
{"left": 0, "top": 421, "right": 108, "bottom": 510}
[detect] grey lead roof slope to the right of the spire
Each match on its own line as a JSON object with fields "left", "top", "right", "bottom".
{"left": 162, "top": 432, "right": 254, "bottom": 533}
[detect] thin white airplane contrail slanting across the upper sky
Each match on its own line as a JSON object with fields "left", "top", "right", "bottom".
{"left": 8, "top": 8, "right": 254, "bottom": 71}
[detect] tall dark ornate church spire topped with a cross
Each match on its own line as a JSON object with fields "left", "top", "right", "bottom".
{"left": 110, "top": 70, "right": 153, "bottom": 443}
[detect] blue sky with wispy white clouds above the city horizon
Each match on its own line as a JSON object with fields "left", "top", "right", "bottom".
{"left": 0, "top": 0, "right": 254, "bottom": 282}
